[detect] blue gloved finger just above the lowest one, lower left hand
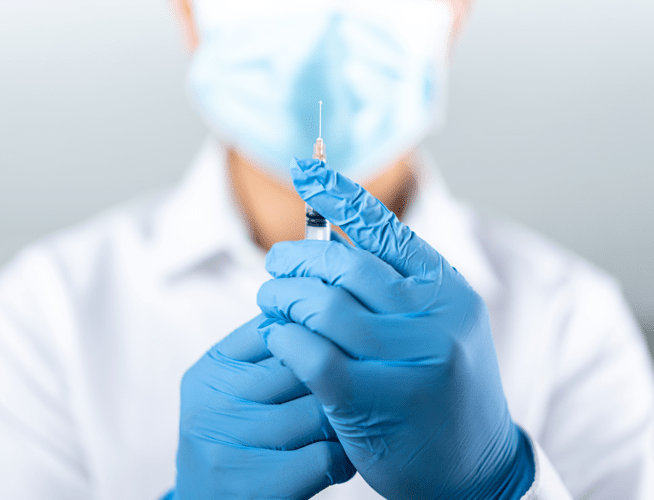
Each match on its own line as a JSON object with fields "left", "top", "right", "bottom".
{"left": 199, "top": 394, "right": 336, "bottom": 450}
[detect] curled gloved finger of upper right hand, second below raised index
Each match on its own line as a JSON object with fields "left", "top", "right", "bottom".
{"left": 257, "top": 278, "right": 440, "bottom": 361}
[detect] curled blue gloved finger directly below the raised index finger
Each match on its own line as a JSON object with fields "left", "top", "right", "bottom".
{"left": 266, "top": 240, "right": 438, "bottom": 313}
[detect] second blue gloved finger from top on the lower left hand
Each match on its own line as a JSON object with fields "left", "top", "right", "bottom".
{"left": 188, "top": 348, "right": 309, "bottom": 403}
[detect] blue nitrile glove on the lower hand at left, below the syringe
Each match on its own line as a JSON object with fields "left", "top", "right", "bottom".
{"left": 171, "top": 315, "right": 354, "bottom": 500}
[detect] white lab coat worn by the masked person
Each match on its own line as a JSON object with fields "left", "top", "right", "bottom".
{"left": 0, "top": 138, "right": 654, "bottom": 500}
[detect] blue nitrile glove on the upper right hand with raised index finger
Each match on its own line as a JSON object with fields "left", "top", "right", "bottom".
{"left": 258, "top": 160, "right": 534, "bottom": 500}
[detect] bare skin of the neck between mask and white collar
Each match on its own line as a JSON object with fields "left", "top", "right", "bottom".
{"left": 227, "top": 148, "right": 418, "bottom": 251}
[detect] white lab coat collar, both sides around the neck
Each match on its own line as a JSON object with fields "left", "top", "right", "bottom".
{"left": 154, "top": 139, "right": 499, "bottom": 298}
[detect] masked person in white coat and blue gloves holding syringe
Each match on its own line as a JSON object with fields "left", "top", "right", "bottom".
{"left": 0, "top": 0, "right": 654, "bottom": 500}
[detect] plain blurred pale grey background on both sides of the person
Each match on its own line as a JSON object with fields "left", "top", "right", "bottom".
{"left": 0, "top": 0, "right": 654, "bottom": 349}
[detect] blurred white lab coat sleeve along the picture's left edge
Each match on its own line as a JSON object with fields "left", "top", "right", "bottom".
{"left": 0, "top": 250, "right": 93, "bottom": 500}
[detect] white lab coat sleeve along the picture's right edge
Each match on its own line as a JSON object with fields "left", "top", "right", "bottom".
{"left": 526, "top": 269, "right": 654, "bottom": 500}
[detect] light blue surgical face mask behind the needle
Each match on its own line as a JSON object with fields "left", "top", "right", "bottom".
{"left": 188, "top": 0, "right": 452, "bottom": 184}
